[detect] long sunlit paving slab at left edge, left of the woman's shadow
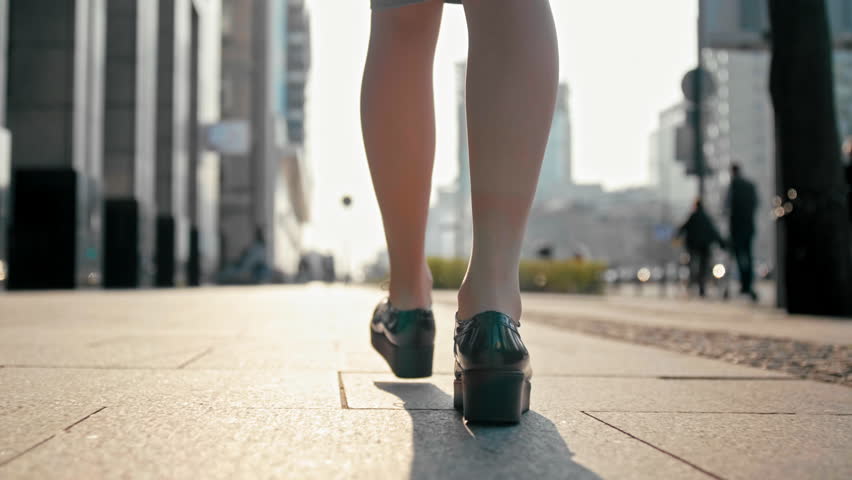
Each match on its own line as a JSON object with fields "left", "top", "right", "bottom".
{"left": 0, "top": 368, "right": 340, "bottom": 462}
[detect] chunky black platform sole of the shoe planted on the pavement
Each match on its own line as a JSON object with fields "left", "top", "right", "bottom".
{"left": 453, "top": 370, "right": 532, "bottom": 423}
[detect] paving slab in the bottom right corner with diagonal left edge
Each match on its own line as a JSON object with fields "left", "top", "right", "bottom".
{"left": 591, "top": 413, "right": 852, "bottom": 480}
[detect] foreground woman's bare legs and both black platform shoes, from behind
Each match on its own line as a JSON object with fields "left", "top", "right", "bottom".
{"left": 361, "top": 0, "right": 558, "bottom": 423}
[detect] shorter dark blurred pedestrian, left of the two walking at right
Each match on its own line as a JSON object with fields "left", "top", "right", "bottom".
{"left": 678, "top": 200, "right": 725, "bottom": 297}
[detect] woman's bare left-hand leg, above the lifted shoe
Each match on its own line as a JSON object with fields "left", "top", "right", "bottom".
{"left": 361, "top": 0, "right": 443, "bottom": 309}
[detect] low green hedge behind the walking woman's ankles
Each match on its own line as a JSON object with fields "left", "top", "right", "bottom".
{"left": 428, "top": 257, "right": 606, "bottom": 294}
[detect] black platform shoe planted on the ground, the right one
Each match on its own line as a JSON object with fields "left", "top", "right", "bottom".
{"left": 453, "top": 311, "right": 532, "bottom": 423}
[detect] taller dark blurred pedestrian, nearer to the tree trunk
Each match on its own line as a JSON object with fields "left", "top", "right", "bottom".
{"left": 726, "top": 163, "right": 757, "bottom": 302}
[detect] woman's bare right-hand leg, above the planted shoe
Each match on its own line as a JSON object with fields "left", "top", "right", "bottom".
{"left": 458, "top": 0, "right": 559, "bottom": 319}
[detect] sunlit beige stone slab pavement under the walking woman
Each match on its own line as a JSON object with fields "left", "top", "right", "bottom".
{"left": 0, "top": 285, "right": 852, "bottom": 479}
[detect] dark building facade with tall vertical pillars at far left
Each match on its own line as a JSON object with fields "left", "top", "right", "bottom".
{"left": 0, "top": 0, "right": 221, "bottom": 289}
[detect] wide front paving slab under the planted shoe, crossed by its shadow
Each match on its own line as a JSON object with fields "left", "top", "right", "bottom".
{"left": 0, "top": 404, "right": 706, "bottom": 479}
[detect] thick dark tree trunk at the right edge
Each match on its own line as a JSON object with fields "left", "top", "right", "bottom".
{"left": 769, "top": 0, "right": 852, "bottom": 315}
